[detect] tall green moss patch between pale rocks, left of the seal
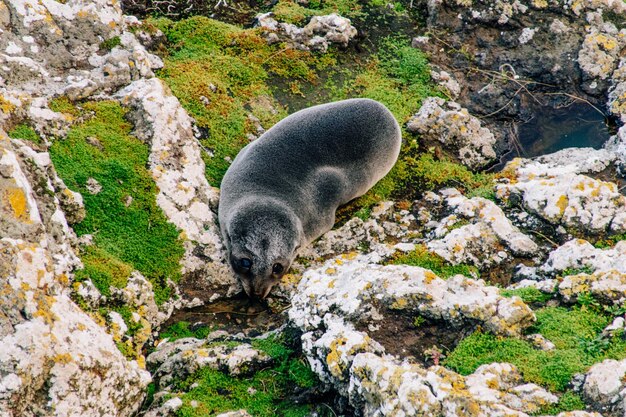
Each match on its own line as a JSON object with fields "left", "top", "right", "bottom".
{"left": 50, "top": 101, "right": 184, "bottom": 303}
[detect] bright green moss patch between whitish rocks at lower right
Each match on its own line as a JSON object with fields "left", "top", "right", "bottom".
{"left": 445, "top": 307, "right": 626, "bottom": 391}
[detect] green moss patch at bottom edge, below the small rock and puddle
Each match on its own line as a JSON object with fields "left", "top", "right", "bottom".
{"left": 178, "top": 337, "right": 319, "bottom": 417}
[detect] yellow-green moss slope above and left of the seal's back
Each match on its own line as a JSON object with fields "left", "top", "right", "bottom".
{"left": 151, "top": 17, "right": 342, "bottom": 185}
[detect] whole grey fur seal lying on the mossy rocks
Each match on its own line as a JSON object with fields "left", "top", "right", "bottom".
{"left": 218, "top": 99, "right": 402, "bottom": 298}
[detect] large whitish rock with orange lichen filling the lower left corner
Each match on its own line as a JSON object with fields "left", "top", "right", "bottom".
{"left": 0, "top": 131, "right": 150, "bottom": 416}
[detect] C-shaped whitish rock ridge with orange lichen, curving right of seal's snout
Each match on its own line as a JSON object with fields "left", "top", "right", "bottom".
{"left": 289, "top": 257, "right": 557, "bottom": 416}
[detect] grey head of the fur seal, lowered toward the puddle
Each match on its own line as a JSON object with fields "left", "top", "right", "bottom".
{"left": 225, "top": 204, "right": 302, "bottom": 299}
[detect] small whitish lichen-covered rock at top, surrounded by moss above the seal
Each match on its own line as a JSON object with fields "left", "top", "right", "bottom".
{"left": 256, "top": 12, "right": 357, "bottom": 52}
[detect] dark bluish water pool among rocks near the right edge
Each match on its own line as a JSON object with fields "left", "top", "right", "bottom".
{"left": 512, "top": 102, "right": 615, "bottom": 157}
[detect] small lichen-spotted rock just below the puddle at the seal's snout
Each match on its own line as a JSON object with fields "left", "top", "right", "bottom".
{"left": 147, "top": 332, "right": 272, "bottom": 388}
